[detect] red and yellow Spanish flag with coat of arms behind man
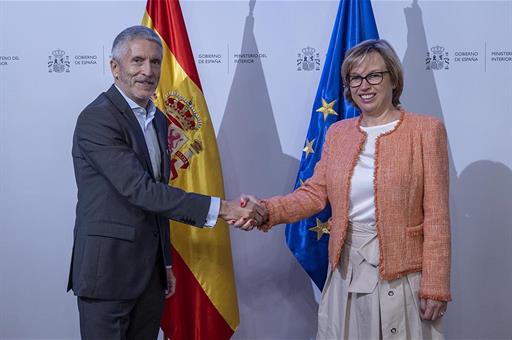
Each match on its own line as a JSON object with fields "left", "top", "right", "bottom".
{"left": 142, "top": 0, "right": 240, "bottom": 340}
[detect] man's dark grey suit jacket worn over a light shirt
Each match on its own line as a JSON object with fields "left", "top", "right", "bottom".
{"left": 68, "top": 86, "right": 210, "bottom": 300}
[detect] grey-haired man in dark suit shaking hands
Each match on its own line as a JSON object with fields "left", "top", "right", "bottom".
{"left": 68, "top": 26, "right": 265, "bottom": 340}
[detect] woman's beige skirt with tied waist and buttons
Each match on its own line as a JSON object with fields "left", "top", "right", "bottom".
{"left": 317, "top": 226, "right": 444, "bottom": 340}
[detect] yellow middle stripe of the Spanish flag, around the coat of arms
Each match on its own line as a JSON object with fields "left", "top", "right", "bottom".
{"left": 143, "top": 12, "right": 240, "bottom": 330}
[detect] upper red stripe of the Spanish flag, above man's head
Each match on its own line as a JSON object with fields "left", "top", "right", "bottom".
{"left": 146, "top": 0, "right": 203, "bottom": 91}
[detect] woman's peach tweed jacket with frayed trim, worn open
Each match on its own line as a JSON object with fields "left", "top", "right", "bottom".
{"left": 263, "top": 111, "right": 451, "bottom": 301}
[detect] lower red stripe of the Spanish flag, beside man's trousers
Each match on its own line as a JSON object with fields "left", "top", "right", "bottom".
{"left": 161, "top": 247, "right": 233, "bottom": 340}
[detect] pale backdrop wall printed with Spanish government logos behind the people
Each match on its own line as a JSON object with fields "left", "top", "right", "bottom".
{"left": 0, "top": 0, "right": 512, "bottom": 339}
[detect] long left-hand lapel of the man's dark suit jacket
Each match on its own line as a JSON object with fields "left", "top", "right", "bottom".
{"left": 105, "top": 85, "right": 155, "bottom": 178}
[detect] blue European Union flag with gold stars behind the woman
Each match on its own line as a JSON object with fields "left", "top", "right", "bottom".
{"left": 286, "top": 0, "right": 379, "bottom": 290}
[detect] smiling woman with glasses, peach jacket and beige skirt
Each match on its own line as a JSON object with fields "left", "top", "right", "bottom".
{"left": 245, "top": 40, "right": 451, "bottom": 339}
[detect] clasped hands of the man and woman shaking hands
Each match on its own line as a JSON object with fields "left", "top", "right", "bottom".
{"left": 219, "top": 195, "right": 270, "bottom": 231}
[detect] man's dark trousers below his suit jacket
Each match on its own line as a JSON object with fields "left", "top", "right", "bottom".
{"left": 78, "top": 266, "right": 165, "bottom": 340}
